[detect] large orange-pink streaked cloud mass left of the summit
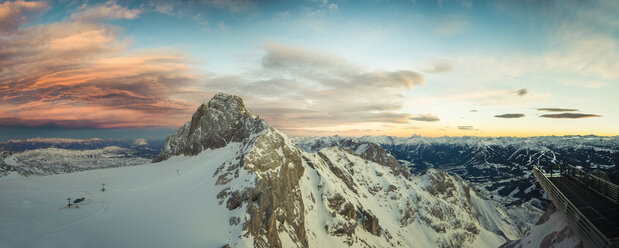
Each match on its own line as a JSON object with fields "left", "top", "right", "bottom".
{"left": 0, "top": 2, "right": 199, "bottom": 128}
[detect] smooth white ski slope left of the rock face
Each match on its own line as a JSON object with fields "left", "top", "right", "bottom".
{"left": 0, "top": 144, "right": 247, "bottom": 248}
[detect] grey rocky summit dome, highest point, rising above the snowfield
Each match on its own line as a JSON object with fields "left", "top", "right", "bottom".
{"left": 153, "top": 93, "right": 268, "bottom": 162}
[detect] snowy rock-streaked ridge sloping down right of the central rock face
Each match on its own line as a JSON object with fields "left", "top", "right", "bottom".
{"left": 301, "top": 147, "right": 520, "bottom": 247}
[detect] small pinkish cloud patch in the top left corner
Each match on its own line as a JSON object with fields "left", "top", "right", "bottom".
{"left": 0, "top": 0, "right": 49, "bottom": 35}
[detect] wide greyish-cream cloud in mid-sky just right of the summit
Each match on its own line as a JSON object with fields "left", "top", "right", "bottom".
{"left": 204, "top": 43, "right": 425, "bottom": 135}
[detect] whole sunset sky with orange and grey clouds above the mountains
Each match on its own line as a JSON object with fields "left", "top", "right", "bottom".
{"left": 0, "top": 0, "right": 619, "bottom": 139}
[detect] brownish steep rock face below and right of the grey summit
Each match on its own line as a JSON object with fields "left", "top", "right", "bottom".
{"left": 243, "top": 127, "right": 308, "bottom": 247}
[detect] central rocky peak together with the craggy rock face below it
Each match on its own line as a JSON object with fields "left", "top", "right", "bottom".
{"left": 154, "top": 93, "right": 308, "bottom": 247}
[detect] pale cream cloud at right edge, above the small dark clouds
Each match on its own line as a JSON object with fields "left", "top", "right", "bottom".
{"left": 456, "top": 34, "right": 619, "bottom": 81}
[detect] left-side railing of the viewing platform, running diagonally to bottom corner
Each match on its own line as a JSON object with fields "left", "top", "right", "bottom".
{"left": 533, "top": 166, "right": 616, "bottom": 247}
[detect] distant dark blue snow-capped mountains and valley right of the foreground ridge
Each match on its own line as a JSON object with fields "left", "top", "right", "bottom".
{"left": 293, "top": 136, "right": 619, "bottom": 210}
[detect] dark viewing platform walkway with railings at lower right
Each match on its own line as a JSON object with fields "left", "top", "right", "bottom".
{"left": 533, "top": 165, "right": 619, "bottom": 247}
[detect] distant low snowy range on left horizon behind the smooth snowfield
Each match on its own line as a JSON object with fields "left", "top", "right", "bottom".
{"left": 0, "top": 138, "right": 164, "bottom": 176}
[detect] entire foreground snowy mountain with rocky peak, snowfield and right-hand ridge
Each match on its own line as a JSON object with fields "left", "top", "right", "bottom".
{"left": 0, "top": 94, "right": 521, "bottom": 247}
